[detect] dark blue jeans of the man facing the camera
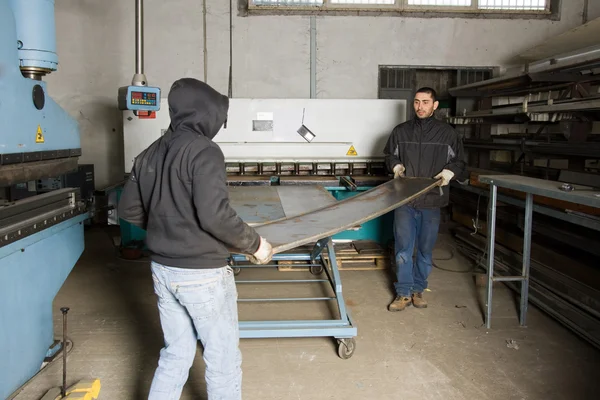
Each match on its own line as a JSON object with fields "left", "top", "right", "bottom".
{"left": 394, "top": 206, "right": 440, "bottom": 297}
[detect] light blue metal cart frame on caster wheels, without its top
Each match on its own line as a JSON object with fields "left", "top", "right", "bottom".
{"left": 230, "top": 237, "right": 357, "bottom": 359}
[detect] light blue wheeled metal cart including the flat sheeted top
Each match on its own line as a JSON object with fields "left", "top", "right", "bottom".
{"left": 229, "top": 186, "right": 357, "bottom": 359}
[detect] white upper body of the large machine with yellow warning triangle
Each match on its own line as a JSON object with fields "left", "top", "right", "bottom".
{"left": 123, "top": 96, "right": 407, "bottom": 184}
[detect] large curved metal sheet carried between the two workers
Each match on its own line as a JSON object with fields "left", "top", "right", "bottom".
{"left": 247, "top": 178, "right": 440, "bottom": 253}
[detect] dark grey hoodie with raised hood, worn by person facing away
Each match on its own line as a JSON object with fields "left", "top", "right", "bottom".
{"left": 119, "top": 78, "right": 260, "bottom": 268}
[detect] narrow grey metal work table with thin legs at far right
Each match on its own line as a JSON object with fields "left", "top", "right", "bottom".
{"left": 479, "top": 175, "right": 600, "bottom": 329}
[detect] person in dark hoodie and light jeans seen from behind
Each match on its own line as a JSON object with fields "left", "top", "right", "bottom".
{"left": 119, "top": 78, "right": 273, "bottom": 400}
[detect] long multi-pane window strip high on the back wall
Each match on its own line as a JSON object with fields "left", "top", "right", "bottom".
{"left": 247, "top": 0, "right": 561, "bottom": 16}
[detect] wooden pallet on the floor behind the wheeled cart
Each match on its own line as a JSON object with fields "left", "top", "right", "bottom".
{"left": 278, "top": 240, "right": 390, "bottom": 272}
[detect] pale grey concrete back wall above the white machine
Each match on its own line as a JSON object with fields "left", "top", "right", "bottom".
{"left": 47, "top": 0, "right": 599, "bottom": 188}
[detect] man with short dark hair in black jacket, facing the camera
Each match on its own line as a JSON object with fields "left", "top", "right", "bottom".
{"left": 384, "top": 88, "right": 465, "bottom": 311}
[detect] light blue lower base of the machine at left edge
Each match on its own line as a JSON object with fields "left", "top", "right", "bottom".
{"left": 0, "top": 214, "right": 89, "bottom": 399}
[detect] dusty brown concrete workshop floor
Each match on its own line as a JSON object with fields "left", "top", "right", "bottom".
{"left": 9, "top": 229, "right": 600, "bottom": 400}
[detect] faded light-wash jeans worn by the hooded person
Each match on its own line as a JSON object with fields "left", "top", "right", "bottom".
{"left": 148, "top": 262, "right": 242, "bottom": 400}
